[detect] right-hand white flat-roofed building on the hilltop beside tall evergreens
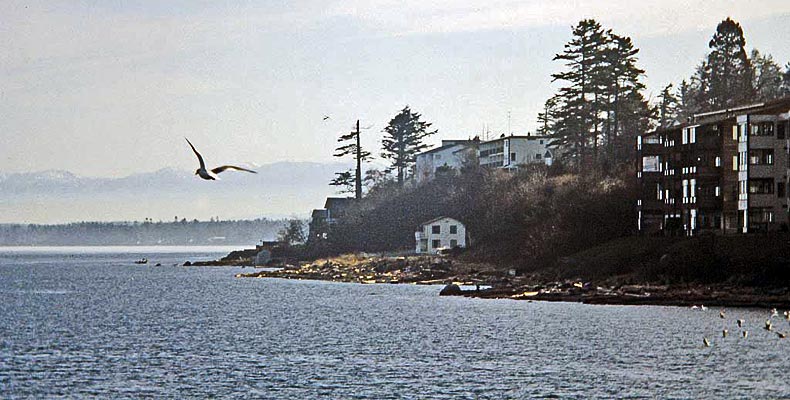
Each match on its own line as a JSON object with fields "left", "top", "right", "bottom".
{"left": 477, "top": 135, "right": 553, "bottom": 169}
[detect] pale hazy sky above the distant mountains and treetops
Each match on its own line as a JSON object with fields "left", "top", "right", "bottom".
{"left": 0, "top": 0, "right": 790, "bottom": 176}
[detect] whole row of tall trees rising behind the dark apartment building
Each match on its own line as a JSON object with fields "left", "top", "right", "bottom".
{"left": 537, "top": 18, "right": 790, "bottom": 168}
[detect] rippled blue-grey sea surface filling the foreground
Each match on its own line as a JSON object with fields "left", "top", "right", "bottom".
{"left": 0, "top": 248, "right": 790, "bottom": 399}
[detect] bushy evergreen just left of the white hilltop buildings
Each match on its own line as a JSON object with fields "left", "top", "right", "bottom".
{"left": 381, "top": 106, "right": 436, "bottom": 186}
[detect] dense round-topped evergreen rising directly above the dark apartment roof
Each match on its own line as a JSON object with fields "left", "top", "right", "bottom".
{"left": 700, "top": 18, "right": 754, "bottom": 111}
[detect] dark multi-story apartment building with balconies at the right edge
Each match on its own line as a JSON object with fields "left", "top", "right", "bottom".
{"left": 637, "top": 98, "right": 790, "bottom": 235}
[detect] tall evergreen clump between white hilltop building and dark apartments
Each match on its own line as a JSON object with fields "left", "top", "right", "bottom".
{"left": 538, "top": 20, "right": 651, "bottom": 166}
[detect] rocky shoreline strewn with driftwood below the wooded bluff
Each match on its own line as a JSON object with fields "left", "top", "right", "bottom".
{"left": 236, "top": 255, "right": 790, "bottom": 309}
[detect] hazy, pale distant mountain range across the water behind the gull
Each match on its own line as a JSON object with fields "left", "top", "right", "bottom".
{"left": 0, "top": 162, "right": 349, "bottom": 223}
